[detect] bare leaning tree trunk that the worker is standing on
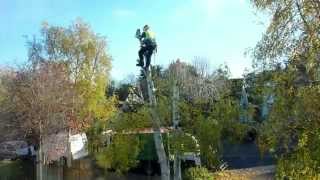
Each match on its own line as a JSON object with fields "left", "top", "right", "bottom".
{"left": 143, "top": 70, "right": 170, "bottom": 180}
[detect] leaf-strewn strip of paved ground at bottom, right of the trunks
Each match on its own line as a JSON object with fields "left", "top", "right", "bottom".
{"left": 216, "top": 166, "right": 275, "bottom": 180}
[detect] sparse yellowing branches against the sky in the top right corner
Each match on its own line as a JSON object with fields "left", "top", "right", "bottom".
{"left": 251, "top": 0, "right": 320, "bottom": 71}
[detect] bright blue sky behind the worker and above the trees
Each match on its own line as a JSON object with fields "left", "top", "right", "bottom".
{"left": 0, "top": 0, "right": 267, "bottom": 80}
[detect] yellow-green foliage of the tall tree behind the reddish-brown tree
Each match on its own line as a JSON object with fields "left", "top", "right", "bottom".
{"left": 35, "top": 20, "right": 115, "bottom": 130}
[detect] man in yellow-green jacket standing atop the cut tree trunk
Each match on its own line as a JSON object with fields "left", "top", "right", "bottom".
{"left": 136, "top": 25, "right": 157, "bottom": 69}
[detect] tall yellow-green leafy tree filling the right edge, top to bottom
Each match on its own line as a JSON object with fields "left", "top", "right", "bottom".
{"left": 252, "top": 0, "right": 320, "bottom": 179}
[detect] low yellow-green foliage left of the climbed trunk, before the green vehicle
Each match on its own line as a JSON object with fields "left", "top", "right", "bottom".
{"left": 87, "top": 107, "right": 153, "bottom": 173}
